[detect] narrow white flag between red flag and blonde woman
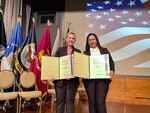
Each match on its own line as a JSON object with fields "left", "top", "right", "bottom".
{"left": 51, "top": 27, "right": 60, "bottom": 56}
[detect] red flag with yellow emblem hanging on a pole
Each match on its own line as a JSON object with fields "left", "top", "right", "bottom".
{"left": 29, "top": 25, "right": 51, "bottom": 96}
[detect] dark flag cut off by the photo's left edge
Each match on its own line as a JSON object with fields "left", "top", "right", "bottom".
{"left": 0, "top": 11, "right": 6, "bottom": 60}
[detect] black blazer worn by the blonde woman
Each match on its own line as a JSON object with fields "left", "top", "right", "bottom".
{"left": 54, "top": 46, "right": 81, "bottom": 87}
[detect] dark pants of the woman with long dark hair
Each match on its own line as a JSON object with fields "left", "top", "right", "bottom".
{"left": 84, "top": 80, "right": 109, "bottom": 113}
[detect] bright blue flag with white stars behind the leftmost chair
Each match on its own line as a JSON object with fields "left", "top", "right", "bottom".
{"left": 1, "top": 21, "right": 23, "bottom": 71}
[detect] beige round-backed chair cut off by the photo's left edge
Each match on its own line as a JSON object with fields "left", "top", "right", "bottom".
{"left": 0, "top": 71, "right": 19, "bottom": 113}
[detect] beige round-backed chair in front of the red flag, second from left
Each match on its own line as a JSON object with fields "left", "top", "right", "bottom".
{"left": 19, "top": 71, "right": 42, "bottom": 113}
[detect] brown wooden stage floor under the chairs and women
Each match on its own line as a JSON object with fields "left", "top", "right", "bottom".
{"left": 0, "top": 99, "right": 150, "bottom": 113}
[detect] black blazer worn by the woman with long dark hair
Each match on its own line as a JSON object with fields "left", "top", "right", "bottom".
{"left": 82, "top": 47, "right": 115, "bottom": 82}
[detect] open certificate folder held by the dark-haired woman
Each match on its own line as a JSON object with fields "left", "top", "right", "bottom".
{"left": 73, "top": 52, "right": 110, "bottom": 79}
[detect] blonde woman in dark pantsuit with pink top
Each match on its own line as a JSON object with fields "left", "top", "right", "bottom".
{"left": 53, "top": 32, "right": 81, "bottom": 113}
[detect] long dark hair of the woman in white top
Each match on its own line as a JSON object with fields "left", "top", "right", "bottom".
{"left": 85, "top": 33, "right": 101, "bottom": 51}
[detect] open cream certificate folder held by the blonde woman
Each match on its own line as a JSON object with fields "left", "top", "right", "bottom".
{"left": 41, "top": 55, "right": 74, "bottom": 80}
